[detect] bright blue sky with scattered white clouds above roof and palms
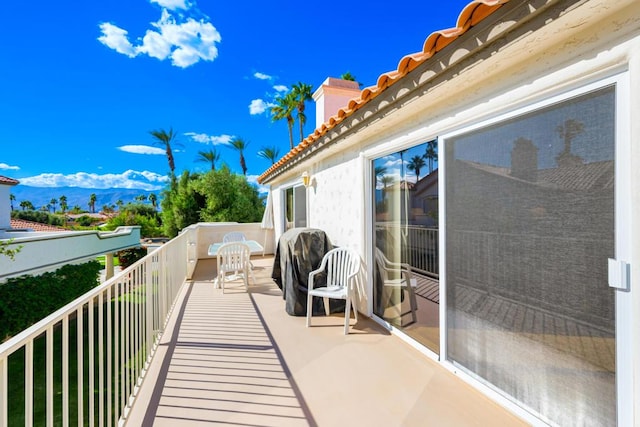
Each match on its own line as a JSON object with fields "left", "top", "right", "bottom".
{"left": 0, "top": 0, "right": 468, "bottom": 190}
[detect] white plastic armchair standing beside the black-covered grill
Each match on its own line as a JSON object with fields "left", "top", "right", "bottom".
{"left": 307, "top": 248, "right": 360, "bottom": 335}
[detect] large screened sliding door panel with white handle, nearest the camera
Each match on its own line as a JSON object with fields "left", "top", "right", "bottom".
{"left": 443, "top": 85, "right": 616, "bottom": 426}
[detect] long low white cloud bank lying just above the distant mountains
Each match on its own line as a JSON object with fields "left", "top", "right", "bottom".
{"left": 20, "top": 170, "right": 169, "bottom": 191}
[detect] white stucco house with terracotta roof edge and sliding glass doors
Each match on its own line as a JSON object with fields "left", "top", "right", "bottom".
{"left": 259, "top": 0, "right": 640, "bottom": 426}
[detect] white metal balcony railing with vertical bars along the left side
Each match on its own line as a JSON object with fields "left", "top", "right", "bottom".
{"left": 0, "top": 228, "right": 191, "bottom": 427}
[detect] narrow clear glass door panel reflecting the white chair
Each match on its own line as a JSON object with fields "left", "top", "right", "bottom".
{"left": 372, "top": 140, "right": 440, "bottom": 352}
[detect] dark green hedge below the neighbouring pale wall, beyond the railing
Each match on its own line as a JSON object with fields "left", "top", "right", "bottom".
{"left": 0, "top": 261, "right": 101, "bottom": 341}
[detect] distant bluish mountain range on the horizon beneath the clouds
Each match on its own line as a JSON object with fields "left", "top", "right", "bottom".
{"left": 11, "top": 184, "right": 161, "bottom": 211}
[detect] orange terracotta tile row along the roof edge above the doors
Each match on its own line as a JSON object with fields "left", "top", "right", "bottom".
{"left": 258, "top": 0, "right": 510, "bottom": 183}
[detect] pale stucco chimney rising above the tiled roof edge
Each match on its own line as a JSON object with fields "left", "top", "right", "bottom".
{"left": 313, "top": 77, "right": 360, "bottom": 129}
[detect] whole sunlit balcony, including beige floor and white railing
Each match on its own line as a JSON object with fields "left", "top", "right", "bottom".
{"left": 0, "top": 224, "right": 525, "bottom": 426}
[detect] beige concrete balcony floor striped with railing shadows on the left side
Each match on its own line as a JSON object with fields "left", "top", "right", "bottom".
{"left": 122, "top": 257, "right": 526, "bottom": 427}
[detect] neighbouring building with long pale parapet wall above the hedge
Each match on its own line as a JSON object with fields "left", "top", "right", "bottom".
{"left": 0, "top": 175, "right": 140, "bottom": 286}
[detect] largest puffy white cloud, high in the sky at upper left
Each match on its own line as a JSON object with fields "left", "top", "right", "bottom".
{"left": 98, "top": 5, "right": 222, "bottom": 68}
